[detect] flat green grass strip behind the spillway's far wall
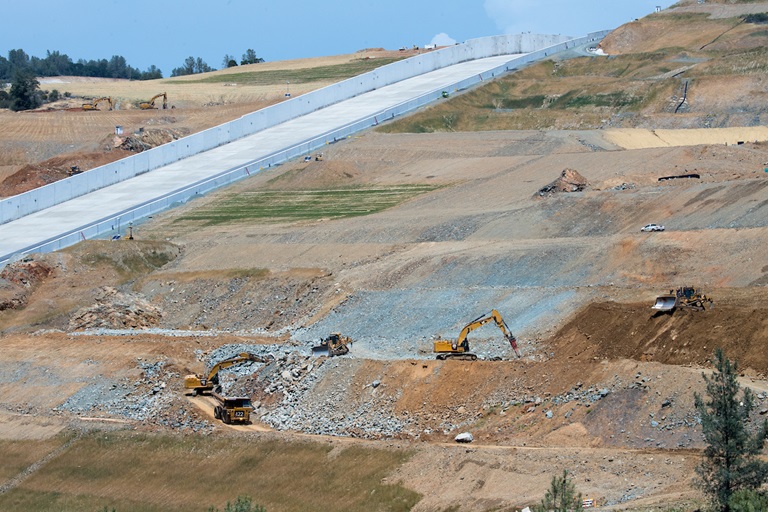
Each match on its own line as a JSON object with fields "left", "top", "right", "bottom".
{"left": 173, "top": 57, "right": 403, "bottom": 85}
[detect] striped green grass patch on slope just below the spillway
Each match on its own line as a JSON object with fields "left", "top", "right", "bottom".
{"left": 174, "top": 185, "right": 438, "bottom": 226}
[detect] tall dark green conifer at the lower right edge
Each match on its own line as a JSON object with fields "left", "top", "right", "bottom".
{"left": 694, "top": 349, "right": 768, "bottom": 512}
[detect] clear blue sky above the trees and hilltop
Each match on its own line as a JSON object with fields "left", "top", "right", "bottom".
{"left": 0, "top": 0, "right": 674, "bottom": 77}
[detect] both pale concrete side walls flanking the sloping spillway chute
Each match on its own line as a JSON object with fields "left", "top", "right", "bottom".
{"left": 0, "top": 31, "right": 607, "bottom": 268}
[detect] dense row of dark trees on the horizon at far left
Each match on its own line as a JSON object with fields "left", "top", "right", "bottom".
{"left": 0, "top": 49, "right": 163, "bottom": 81}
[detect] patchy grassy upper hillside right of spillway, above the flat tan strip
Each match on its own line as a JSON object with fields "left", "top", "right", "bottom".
{"left": 382, "top": 1, "right": 768, "bottom": 133}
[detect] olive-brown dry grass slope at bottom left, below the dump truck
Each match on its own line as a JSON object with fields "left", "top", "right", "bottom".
{"left": 0, "top": 432, "right": 420, "bottom": 512}
